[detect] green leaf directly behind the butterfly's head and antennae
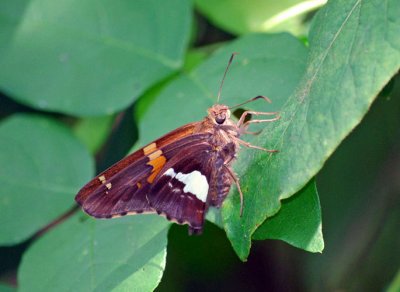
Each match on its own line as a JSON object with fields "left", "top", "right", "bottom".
{"left": 137, "top": 34, "right": 307, "bottom": 146}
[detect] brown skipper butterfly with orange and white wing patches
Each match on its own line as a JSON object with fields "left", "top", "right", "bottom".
{"left": 75, "top": 53, "right": 279, "bottom": 234}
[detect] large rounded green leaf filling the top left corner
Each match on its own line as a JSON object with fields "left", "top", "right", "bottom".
{"left": 0, "top": 0, "right": 192, "bottom": 116}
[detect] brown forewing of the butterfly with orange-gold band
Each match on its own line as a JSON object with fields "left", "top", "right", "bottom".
{"left": 75, "top": 123, "right": 212, "bottom": 218}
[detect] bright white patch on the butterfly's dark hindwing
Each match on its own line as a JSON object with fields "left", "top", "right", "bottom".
{"left": 176, "top": 168, "right": 208, "bottom": 203}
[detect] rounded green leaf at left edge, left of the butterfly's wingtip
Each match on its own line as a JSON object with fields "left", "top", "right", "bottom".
{"left": 0, "top": 115, "right": 94, "bottom": 245}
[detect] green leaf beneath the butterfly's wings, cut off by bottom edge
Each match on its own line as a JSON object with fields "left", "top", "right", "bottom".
{"left": 18, "top": 214, "right": 170, "bottom": 291}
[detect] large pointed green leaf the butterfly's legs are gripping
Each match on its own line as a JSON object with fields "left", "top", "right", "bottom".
{"left": 222, "top": 0, "right": 400, "bottom": 259}
